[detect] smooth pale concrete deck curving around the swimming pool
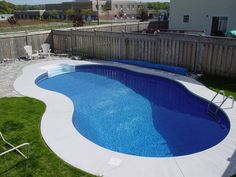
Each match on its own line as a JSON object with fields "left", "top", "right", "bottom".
{"left": 14, "top": 60, "right": 236, "bottom": 177}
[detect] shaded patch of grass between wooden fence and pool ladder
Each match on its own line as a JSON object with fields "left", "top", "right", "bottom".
{"left": 199, "top": 75, "right": 236, "bottom": 99}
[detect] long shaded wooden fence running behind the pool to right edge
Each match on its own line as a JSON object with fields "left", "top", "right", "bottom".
{"left": 53, "top": 30, "right": 236, "bottom": 78}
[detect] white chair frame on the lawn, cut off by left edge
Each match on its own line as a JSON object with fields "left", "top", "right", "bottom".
{"left": 0, "top": 132, "right": 30, "bottom": 159}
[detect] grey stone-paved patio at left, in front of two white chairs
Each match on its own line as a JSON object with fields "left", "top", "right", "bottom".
{"left": 0, "top": 57, "right": 68, "bottom": 98}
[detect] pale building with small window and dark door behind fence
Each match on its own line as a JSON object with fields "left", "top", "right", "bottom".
{"left": 169, "top": 0, "right": 236, "bottom": 35}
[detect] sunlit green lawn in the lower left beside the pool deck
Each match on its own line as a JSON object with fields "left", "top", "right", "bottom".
{"left": 0, "top": 97, "right": 96, "bottom": 177}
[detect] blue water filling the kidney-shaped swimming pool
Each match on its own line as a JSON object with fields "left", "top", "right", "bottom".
{"left": 37, "top": 65, "right": 230, "bottom": 157}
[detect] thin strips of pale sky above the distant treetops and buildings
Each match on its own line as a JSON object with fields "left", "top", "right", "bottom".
{"left": 6, "top": 0, "right": 169, "bottom": 4}
